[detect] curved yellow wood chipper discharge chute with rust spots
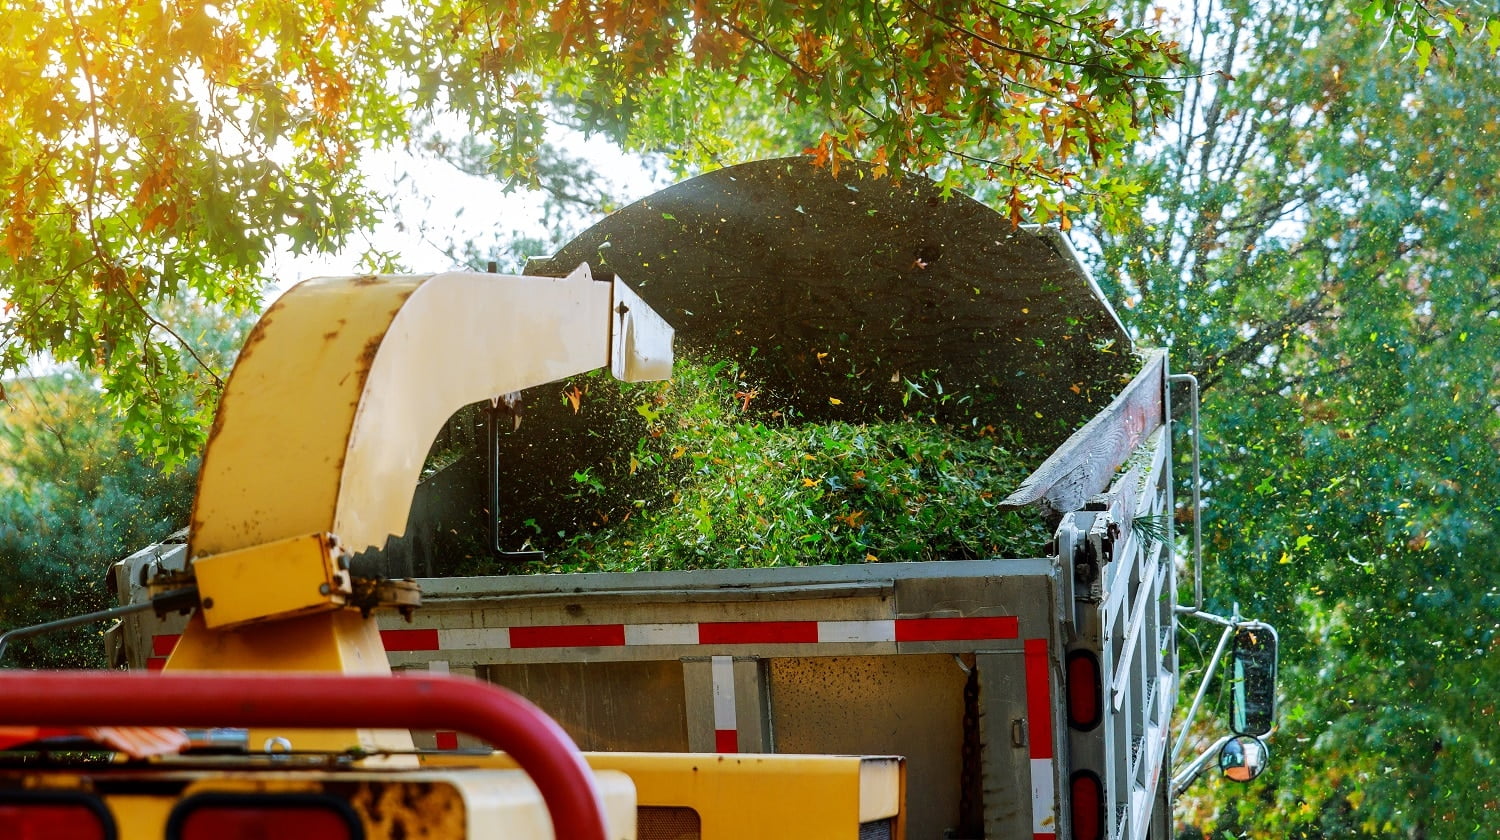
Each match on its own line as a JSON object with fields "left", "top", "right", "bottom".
{"left": 159, "top": 266, "right": 672, "bottom": 750}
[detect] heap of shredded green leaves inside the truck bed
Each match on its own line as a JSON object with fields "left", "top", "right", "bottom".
{"left": 512, "top": 359, "right": 1049, "bottom": 573}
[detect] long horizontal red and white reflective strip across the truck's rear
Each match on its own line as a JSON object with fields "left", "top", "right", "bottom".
{"left": 147, "top": 615, "right": 1017, "bottom": 668}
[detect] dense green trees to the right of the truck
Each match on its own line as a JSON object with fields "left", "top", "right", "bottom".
{"left": 1101, "top": 2, "right": 1500, "bottom": 837}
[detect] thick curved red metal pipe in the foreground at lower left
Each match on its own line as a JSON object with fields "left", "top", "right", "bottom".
{"left": 0, "top": 671, "right": 608, "bottom": 840}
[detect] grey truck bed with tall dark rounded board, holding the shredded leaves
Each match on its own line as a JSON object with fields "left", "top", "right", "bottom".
{"left": 114, "top": 161, "right": 1176, "bottom": 840}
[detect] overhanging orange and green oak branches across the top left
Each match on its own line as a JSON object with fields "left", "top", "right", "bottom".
{"left": 0, "top": 0, "right": 1178, "bottom": 455}
